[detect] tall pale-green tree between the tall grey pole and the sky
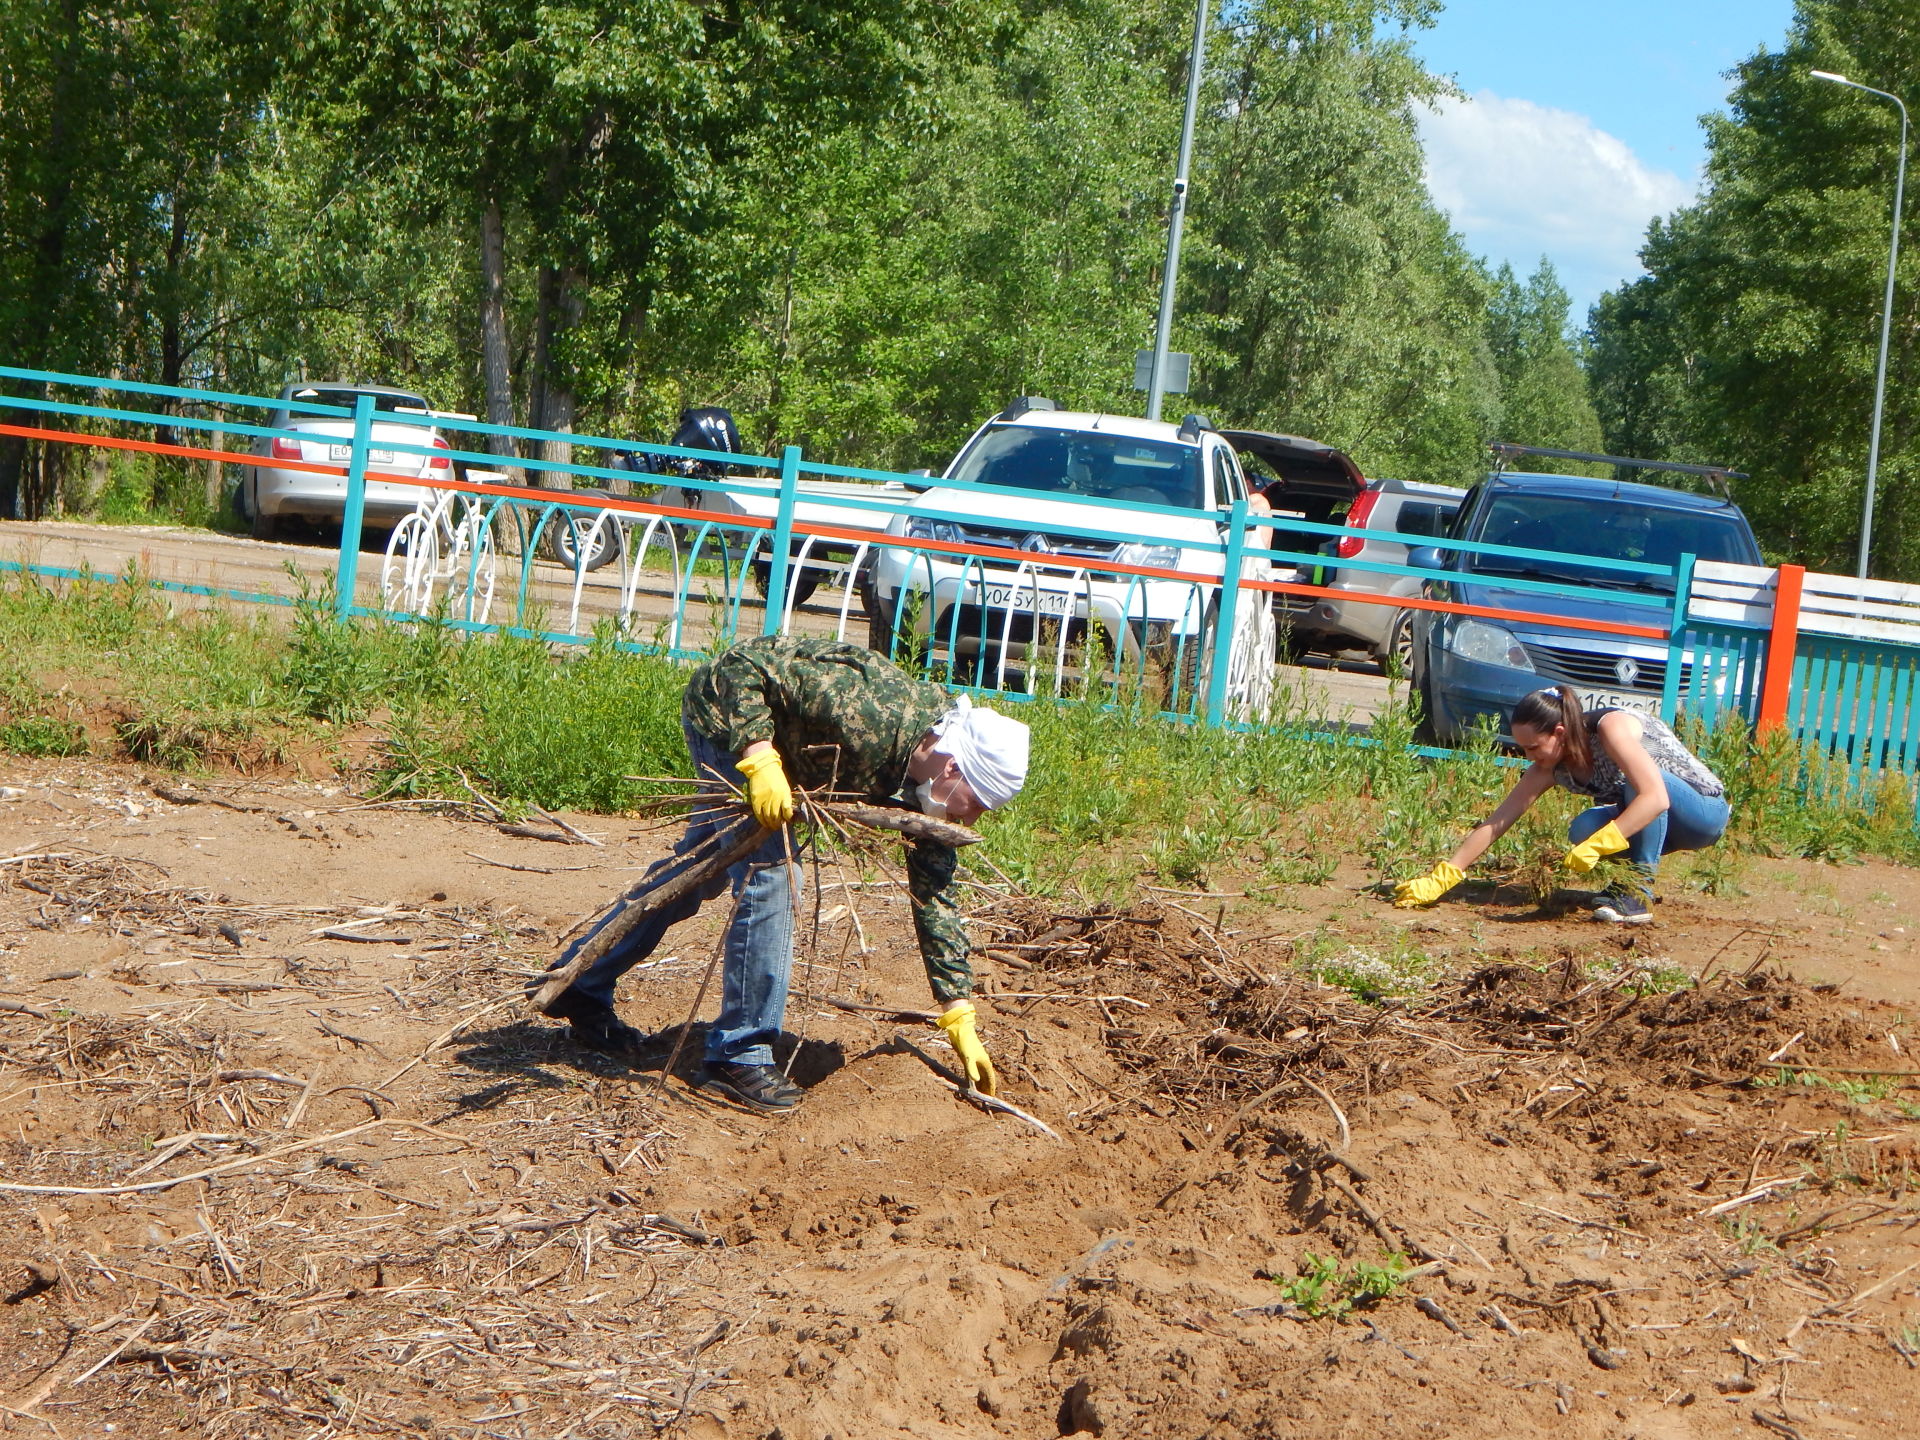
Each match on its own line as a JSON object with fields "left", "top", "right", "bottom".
{"left": 1194, "top": 2, "right": 1500, "bottom": 484}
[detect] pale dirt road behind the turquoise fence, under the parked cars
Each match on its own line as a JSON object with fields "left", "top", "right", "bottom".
{"left": 0, "top": 520, "right": 1388, "bottom": 726}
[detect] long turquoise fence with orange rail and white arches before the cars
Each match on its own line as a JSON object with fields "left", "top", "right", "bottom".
{"left": 0, "top": 367, "right": 1920, "bottom": 794}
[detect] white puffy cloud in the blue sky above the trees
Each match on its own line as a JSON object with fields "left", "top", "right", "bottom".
{"left": 1421, "top": 90, "right": 1693, "bottom": 319}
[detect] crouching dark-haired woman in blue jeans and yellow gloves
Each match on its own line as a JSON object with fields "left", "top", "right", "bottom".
{"left": 1394, "top": 685, "right": 1728, "bottom": 925}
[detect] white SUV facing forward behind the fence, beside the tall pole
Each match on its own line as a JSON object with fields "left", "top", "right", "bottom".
{"left": 866, "top": 396, "right": 1275, "bottom": 718}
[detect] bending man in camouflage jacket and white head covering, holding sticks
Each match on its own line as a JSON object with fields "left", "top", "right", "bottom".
{"left": 547, "top": 636, "right": 1027, "bottom": 1112}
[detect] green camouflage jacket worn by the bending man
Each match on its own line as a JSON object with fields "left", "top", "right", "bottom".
{"left": 680, "top": 636, "right": 973, "bottom": 1000}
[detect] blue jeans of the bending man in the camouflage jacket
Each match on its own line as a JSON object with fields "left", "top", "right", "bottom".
{"left": 555, "top": 726, "right": 793, "bottom": 1066}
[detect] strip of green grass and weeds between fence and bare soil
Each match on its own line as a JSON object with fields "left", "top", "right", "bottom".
{"left": 0, "top": 576, "right": 1920, "bottom": 913}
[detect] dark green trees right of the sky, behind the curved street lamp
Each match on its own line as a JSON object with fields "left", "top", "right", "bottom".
{"left": 1592, "top": 0, "right": 1920, "bottom": 580}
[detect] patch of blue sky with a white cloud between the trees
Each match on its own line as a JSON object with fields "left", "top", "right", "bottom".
{"left": 1413, "top": 0, "right": 1793, "bottom": 321}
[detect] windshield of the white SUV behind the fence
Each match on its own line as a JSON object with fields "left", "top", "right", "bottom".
{"left": 952, "top": 424, "right": 1206, "bottom": 511}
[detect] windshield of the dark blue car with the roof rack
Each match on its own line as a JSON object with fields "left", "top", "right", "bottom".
{"left": 1473, "top": 495, "right": 1757, "bottom": 589}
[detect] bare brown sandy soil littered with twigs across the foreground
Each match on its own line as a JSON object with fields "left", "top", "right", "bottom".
{"left": 0, "top": 760, "right": 1920, "bottom": 1440}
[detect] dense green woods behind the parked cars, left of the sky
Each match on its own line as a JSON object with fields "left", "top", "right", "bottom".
{"left": 0, "top": 0, "right": 1586, "bottom": 515}
